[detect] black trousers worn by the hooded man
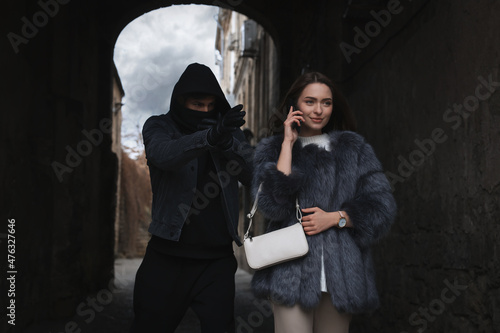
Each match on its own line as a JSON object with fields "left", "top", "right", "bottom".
{"left": 132, "top": 247, "right": 237, "bottom": 333}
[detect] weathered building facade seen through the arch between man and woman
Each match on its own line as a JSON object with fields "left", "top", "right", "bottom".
{"left": 215, "top": 8, "right": 279, "bottom": 270}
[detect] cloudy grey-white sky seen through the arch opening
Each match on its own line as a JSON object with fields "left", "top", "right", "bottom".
{"left": 114, "top": 5, "right": 219, "bottom": 156}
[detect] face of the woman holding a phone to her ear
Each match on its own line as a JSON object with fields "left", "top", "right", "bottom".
{"left": 297, "top": 83, "right": 333, "bottom": 136}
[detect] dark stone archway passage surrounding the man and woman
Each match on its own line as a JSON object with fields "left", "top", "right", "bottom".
{"left": 4, "top": 0, "right": 500, "bottom": 331}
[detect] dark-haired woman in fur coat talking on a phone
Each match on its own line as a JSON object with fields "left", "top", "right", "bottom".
{"left": 252, "top": 72, "right": 396, "bottom": 333}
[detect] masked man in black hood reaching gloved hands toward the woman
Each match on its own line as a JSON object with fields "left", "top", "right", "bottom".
{"left": 132, "top": 63, "right": 253, "bottom": 333}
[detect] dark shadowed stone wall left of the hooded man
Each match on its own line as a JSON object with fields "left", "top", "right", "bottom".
{"left": 0, "top": 0, "right": 117, "bottom": 332}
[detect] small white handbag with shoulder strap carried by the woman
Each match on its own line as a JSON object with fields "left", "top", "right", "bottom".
{"left": 243, "top": 184, "right": 309, "bottom": 270}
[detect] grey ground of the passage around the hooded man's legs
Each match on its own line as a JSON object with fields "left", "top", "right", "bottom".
{"left": 23, "top": 259, "right": 274, "bottom": 333}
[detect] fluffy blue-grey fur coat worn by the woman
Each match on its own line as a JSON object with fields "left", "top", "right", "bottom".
{"left": 252, "top": 131, "right": 396, "bottom": 313}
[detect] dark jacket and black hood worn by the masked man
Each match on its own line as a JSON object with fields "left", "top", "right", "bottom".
{"left": 143, "top": 64, "right": 253, "bottom": 245}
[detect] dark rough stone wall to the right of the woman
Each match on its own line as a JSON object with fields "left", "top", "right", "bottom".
{"left": 343, "top": 0, "right": 500, "bottom": 333}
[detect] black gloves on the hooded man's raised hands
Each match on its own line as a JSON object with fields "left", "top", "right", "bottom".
{"left": 207, "top": 104, "right": 246, "bottom": 145}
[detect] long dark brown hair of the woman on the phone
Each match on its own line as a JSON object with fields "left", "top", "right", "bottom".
{"left": 269, "top": 72, "right": 356, "bottom": 134}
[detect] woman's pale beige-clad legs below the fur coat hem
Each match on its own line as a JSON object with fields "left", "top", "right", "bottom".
{"left": 273, "top": 293, "right": 351, "bottom": 333}
